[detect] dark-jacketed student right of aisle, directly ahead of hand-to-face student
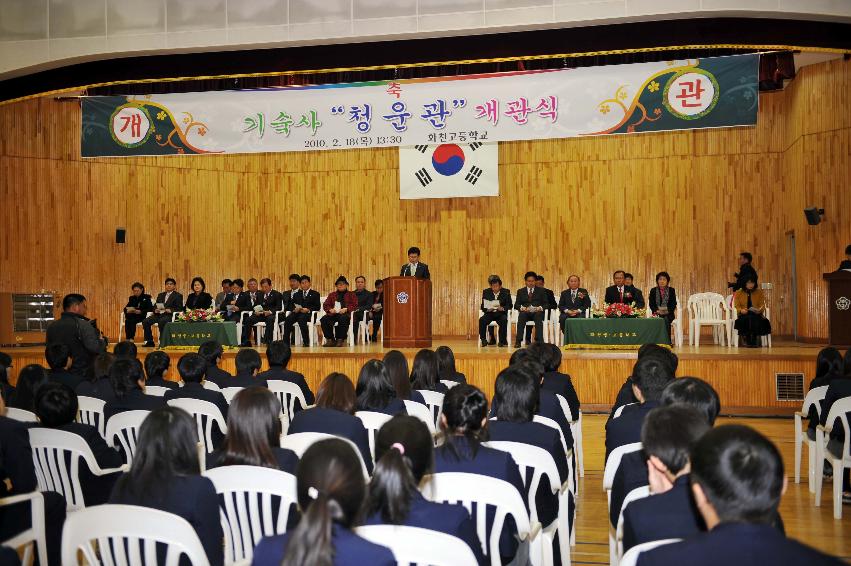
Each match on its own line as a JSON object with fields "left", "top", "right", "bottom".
{"left": 606, "top": 356, "right": 674, "bottom": 459}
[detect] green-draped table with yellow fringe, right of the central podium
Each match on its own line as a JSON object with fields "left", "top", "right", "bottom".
{"left": 564, "top": 317, "right": 671, "bottom": 350}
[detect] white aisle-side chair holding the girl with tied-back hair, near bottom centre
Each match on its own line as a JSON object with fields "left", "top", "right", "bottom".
{"left": 422, "top": 472, "right": 544, "bottom": 566}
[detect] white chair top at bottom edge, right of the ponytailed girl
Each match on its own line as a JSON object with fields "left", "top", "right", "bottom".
{"left": 355, "top": 525, "right": 476, "bottom": 566}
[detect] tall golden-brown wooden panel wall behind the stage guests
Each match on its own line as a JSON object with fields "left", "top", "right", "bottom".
{"left": 0, "top": 60, "right": 851, "bottom": 340}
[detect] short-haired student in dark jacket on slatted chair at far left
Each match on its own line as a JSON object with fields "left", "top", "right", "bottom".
{"left": 35, "top": 383, "right": 123, "bottom": 506}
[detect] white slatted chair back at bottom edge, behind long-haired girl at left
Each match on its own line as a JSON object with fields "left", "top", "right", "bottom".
{"left": 62, "top": 505, "right": 210, "bottom": 566}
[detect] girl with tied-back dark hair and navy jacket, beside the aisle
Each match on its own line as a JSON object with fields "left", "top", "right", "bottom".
{"left": 434, "top": 384, "right": 529, "bottom": 564}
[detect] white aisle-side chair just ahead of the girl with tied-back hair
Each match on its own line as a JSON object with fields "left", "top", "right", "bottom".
{"left": 484, "top": 440, "right": 575, "bottom": 564}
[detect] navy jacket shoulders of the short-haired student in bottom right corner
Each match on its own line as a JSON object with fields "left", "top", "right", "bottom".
{"left": 638, "top": 523, "right": 843, "bottom": 566}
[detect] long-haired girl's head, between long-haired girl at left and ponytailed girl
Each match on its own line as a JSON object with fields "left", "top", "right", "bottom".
{"left": 221, "top": 387, "right": 281, "bottom": 468}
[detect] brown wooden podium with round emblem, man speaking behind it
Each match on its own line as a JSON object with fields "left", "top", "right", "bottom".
{"left": 382, "top": 277, "right": 431, "bottom": 348}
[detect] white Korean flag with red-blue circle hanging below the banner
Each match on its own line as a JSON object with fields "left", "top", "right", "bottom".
{"left": 399, "top": 142, "right": 499, "bottom": 199}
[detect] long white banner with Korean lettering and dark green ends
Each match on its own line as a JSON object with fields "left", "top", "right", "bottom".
{"left": 81, "top": 55, "right": 759, "bottom": 157}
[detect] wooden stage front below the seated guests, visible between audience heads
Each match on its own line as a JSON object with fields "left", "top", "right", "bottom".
{"left": 4, "top": 339, "right": 823, "bottom": 416}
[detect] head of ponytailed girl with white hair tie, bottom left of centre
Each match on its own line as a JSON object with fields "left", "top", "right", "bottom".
{"left": 282, "top": 438, "right": 366, "bottom": 566}
